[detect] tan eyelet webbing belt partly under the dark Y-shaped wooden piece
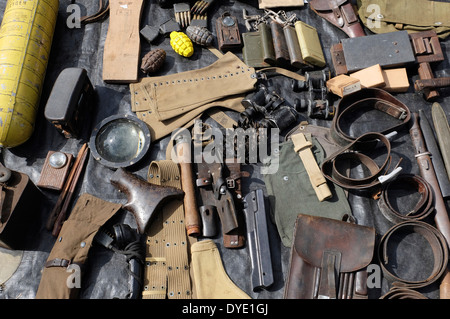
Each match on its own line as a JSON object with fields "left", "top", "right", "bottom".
{"left": 142, "top": 160, "right": 192, "bottom": 299}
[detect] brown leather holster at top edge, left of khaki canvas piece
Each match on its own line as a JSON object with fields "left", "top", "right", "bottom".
{"left": 309, "top": 0, "right": 366, "bottom": 38}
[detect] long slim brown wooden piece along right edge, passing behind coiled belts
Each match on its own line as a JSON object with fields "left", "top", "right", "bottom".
{"left": 409, "top": 112, "right": 450, "bottom": 299}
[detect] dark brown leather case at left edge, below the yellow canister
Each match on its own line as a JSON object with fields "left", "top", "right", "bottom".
{"left": 0, "top": 171, "right": 42, "bottom": 250}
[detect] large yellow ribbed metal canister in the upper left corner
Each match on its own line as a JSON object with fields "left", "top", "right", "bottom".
{"left": 0, "top": 0, "right": 59, "bottom": 148}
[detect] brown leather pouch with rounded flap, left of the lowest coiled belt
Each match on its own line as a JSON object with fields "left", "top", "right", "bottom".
{"left": 284, "top": 214, "right": 375, "bottom": 299}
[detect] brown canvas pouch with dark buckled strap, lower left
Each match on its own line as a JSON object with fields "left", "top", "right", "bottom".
{"left": 36, "top": 193, "right": 122, "bottom": 299}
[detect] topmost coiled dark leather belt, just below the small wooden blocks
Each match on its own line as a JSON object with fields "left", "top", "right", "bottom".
{"left": 331, "top": 88, "right": 411, "bottom": 146}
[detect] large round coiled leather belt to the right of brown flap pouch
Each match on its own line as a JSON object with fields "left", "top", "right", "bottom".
{"left": 378, "top": 221, "right": 448, "bottom": 289}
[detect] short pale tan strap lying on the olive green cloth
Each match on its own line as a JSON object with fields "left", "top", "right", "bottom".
{"left": 291, "top": 133, "right": 332, "bottom": 201}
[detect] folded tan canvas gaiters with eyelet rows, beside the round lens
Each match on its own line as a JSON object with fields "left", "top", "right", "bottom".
{"left": 130, "top": 52, "right": 257, "bottom": 140}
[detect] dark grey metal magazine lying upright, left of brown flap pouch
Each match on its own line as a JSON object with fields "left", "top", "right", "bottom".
{"left": 243, "top": 189, "right": 273, "bottom": 292}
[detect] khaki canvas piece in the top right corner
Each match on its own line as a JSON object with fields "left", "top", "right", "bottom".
{"left": 357, "top": 0, "right": 450, "bottom": 39}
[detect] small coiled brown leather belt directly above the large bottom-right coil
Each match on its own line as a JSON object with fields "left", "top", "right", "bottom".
{"left": 378, "top": 174, "right": 434, "bottom": 224}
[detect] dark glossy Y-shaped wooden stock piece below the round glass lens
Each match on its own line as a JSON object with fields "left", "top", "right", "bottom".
{"left": 110, "top": 168, "right": 184, "bottom": 234}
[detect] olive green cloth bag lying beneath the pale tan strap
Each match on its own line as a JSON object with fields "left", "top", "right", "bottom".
{"left": 264, "top": 136, "right": 352, "bottom": 247}
